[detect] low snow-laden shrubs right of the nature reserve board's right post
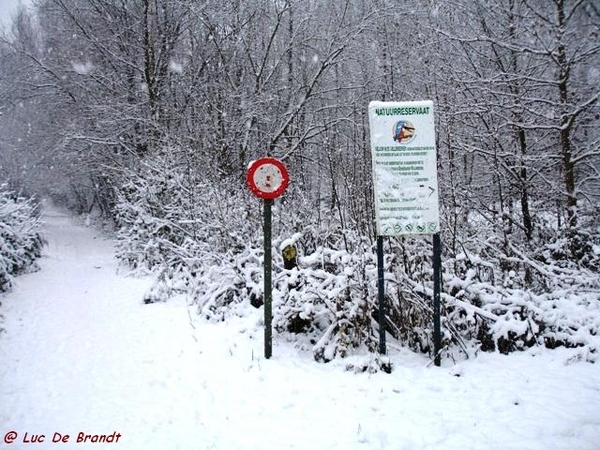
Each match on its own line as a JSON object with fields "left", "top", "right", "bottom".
{"left": 443, "top": 236, "right": 600, "bottom": 360}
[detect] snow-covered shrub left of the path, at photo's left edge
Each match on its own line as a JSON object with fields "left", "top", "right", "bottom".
{"left": 0, "top": 185, "right": 44, "bottom": 292}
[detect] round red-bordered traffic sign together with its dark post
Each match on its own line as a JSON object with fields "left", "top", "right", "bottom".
{"left": 246, "top": 158, "right": 290, "bottom": 359}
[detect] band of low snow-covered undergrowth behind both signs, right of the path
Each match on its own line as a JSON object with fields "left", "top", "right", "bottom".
{"left": 116, "top": 153, "right": 600, "bottom": 370}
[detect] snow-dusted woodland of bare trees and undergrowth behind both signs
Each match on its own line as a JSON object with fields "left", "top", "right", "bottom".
{"left": 0, "top": 0, "right": 600, "bottom": 360}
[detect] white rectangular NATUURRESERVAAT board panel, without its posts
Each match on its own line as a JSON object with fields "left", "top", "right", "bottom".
{"left": 369, "top": 101, "right": 440, "bottom": 236}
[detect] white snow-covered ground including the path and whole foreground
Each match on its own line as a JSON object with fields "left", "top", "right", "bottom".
{"left": 0, "top": 210, "right": 600, "bottom": 450}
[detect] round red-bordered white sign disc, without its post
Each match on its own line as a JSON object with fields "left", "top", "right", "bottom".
{"left": 246, "top": 158, "right": 290, "bottom": 200}
